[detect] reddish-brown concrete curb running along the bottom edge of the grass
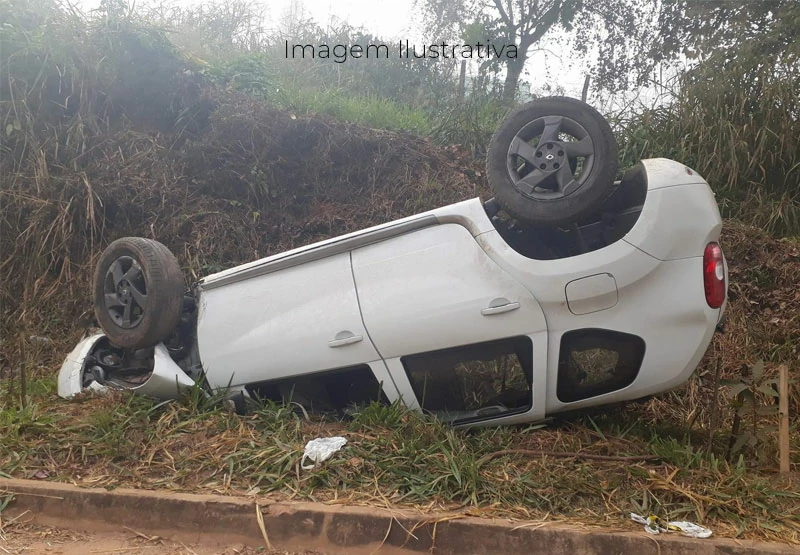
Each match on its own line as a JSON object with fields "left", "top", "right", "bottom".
{"left": 0, "top": 479, "right": 798, "bottom": 555}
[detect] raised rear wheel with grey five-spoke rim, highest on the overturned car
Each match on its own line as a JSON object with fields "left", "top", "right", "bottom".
{"left": 486, "top": 96, "right": 619, "bottom": 226}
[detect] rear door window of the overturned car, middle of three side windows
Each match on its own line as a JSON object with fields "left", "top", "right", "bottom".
{"left": 400, "top": 337, "right": 533, "bottom": 423}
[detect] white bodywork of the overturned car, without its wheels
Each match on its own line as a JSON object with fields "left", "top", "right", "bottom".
{"left": 59, "top": 159, "right": 727, "bottom": 425}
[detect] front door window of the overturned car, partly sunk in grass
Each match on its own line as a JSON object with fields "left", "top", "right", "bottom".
{"left": 247, "top": 364, "right": 389, "bottom": 414}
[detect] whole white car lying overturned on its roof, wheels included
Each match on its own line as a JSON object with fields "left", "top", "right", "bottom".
{"left": 59, "top": 98, "right": 727, "bottom": 425}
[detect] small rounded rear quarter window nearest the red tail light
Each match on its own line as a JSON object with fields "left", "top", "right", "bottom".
{"left": 556, "top": 329, "right": 644, "bottom": 403}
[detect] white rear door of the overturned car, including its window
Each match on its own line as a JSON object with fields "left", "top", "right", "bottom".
{"left": 352, "top": 224, "right": 547, "bottom": 424}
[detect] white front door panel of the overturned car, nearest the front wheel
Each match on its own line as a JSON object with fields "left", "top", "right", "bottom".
{"left": 197, "top": 252, "right": 396, "bottom": 400}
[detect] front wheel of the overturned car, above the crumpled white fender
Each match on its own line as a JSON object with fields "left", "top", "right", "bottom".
{"left": 94, "top": 237, "right": 184, "bottom": 349}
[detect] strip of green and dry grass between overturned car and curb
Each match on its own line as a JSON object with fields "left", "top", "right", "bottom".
{"left": 0, "top": 370, "right": 800, "bottom": 543}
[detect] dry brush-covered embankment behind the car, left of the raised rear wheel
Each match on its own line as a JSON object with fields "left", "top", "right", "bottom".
{"left": 0, "top": 80, "right": 487, "bottom": 364}
